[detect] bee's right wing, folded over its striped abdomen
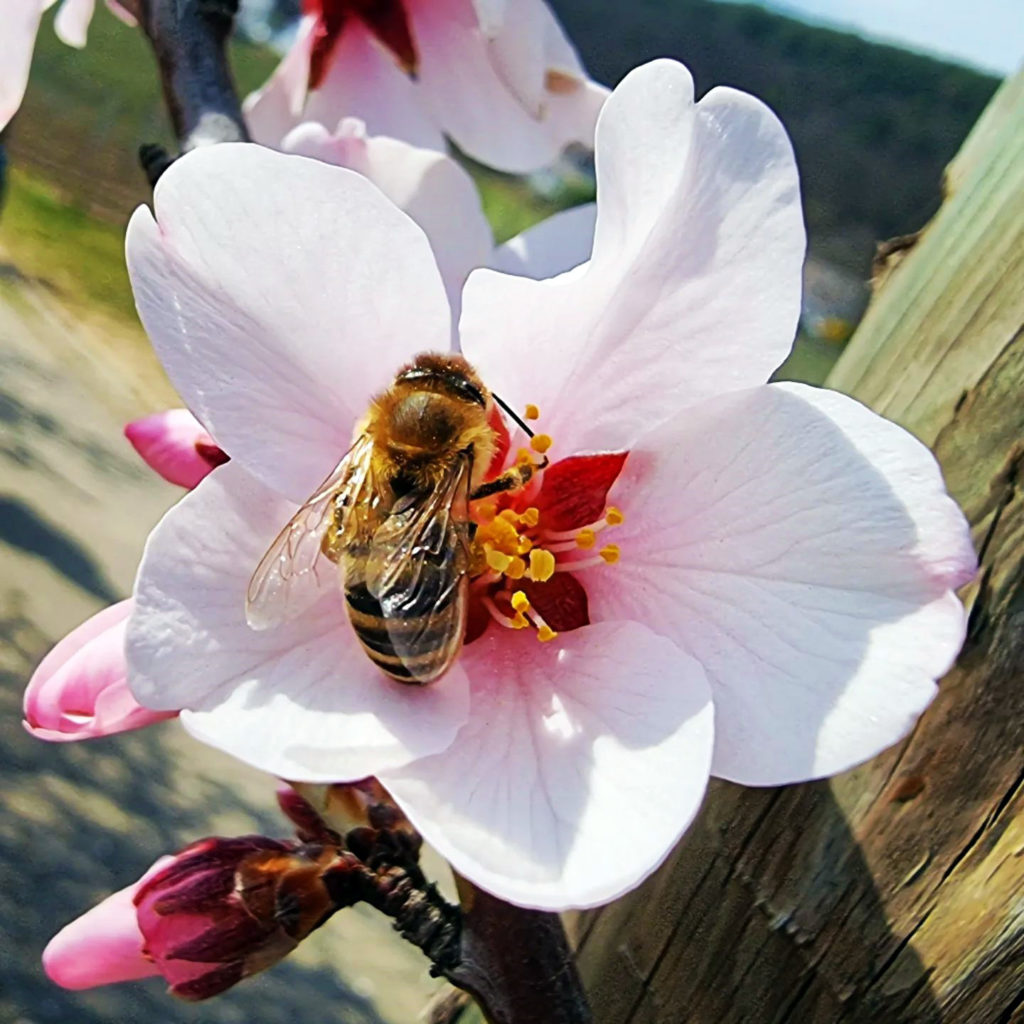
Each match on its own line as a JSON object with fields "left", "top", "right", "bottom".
{"left": 367, "top": 458, "right": 471, "bottom": 682}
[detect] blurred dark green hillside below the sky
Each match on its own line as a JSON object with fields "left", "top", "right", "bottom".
{"left": 551, "top": 0, "right": 998, "bottom": 275}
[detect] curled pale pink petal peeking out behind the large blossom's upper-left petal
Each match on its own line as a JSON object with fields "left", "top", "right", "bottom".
{"left": 282, "top": 119, "right": 494, "bottom": 322}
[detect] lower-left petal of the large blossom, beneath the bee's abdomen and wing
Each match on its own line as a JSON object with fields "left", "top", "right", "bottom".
{"left": 127, "top": 462, "right": 468, "bottom": 782}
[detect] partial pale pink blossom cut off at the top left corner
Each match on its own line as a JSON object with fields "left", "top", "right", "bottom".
{"left": 0, "top": 0, "right": 134, "bottom": 130}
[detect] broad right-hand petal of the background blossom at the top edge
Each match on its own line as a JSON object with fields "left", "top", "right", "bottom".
{"left": 409, "top": 0, "right": 607, "bottom": 172}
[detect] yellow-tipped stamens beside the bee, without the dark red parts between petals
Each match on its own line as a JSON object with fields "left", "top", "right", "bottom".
{"left": 473, "top": 406, "right": 625, "bottom": 642}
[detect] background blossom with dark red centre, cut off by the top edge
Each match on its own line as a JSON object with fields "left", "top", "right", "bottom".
{"left": 245, "top": 0, "right": 607, "bottom": 172}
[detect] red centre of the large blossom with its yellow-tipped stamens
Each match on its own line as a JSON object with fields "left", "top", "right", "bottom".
{"left": 466, "top": 406, "right": 626, "bottom": 642}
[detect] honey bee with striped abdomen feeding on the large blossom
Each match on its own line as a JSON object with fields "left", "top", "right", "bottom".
{"left": 246, "top": 353, "right": 546, "bottom": 685}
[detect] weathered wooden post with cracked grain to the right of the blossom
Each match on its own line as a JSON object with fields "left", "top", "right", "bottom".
{"left": 579, "top": 74, "right": 1024, "bottom": 1024}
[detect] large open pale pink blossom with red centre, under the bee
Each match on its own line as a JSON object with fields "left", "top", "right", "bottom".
{"left": 121, "top": 60, "right": 975, "bottom": 909}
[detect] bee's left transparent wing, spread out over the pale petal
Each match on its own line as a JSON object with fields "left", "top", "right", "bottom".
{"left": 246, "top": 434, "right": 373, "bottom": 630}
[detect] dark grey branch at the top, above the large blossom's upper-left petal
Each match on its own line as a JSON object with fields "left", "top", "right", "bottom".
{"left": 133, "top": 0, "right": 249, "bottom": 185}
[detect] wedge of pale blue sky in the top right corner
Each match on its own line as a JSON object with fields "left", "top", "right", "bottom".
{"left": 764, "top": 0, "right": 1024, "bottom": 75}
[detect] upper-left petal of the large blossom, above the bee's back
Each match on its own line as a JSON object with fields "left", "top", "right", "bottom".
{"left": 127, "top": 143, "right": 451, "bottom": 502}
